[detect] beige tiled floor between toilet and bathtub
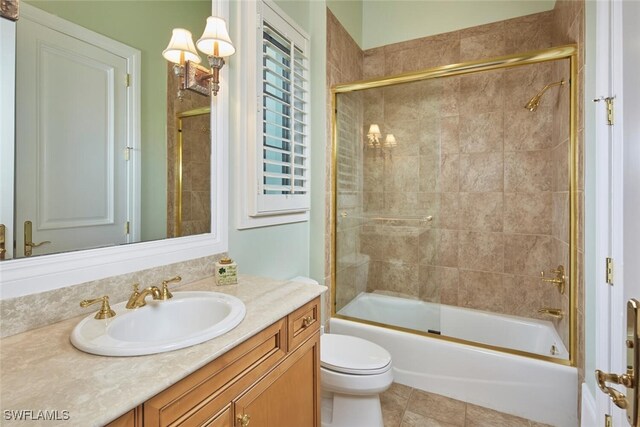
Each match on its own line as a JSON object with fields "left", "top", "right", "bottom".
{"left": 380, "top": 383, "right": 549, "bottom": 427}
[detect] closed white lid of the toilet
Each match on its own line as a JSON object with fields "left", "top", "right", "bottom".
{"left": 320, "top": 334, "right": 391, "bottom": 375}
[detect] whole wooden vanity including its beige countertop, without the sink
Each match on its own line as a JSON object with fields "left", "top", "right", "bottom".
{"left": 0, "top": 276, "right": 326, "bottom": 427}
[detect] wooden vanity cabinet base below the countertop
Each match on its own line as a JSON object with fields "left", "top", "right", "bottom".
{"left": 108, "top": 298, "right": 320, "bottom": 427}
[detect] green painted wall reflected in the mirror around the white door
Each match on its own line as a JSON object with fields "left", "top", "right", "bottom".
{"left": 28, "top": 0, "right": 211, "bottom": 241}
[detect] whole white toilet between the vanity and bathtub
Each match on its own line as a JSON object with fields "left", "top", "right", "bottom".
{"left": 320, "top": 334, "right": 393, "bottom": 427}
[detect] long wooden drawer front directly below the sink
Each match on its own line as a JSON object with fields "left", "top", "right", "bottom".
{"left": 144, "top": 319, "right": 287, "bottom": 426}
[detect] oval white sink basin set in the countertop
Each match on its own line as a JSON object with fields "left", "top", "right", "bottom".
{"left": 71, "top": 292, "right": 246, "bottom": 356}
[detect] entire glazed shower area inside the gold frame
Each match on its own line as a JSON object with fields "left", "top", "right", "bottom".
{"left": 334, "top": 51, "right": 580, "bottom": 363}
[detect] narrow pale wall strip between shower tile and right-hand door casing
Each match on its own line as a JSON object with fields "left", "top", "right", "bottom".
{"left": 583, "top": 1, "right": 602, "bottom": 395}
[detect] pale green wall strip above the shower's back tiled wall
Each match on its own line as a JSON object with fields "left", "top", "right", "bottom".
{"left": 364, "top": 0, "right": 555, "bottom": 49}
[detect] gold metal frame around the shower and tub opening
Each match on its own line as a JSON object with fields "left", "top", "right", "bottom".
{"left": 330, "top": 44, "right": 579, "bottom": 366}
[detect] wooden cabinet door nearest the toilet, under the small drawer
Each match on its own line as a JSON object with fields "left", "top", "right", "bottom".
{"left": 235, "top": 332, "right": 320, "bottom": 427}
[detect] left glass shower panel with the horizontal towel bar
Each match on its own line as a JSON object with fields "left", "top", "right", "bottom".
{"left": 336, "top": 80, "right": 444, "bottom": 334}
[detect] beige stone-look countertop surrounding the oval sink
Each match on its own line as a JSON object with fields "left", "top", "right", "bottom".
{"left": 0, "top": 275, "right": 326, "bottom": 426}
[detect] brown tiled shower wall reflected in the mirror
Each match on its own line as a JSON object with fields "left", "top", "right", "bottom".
{"left": 167, "top": 68, "right": 211, "bottom": 237}
